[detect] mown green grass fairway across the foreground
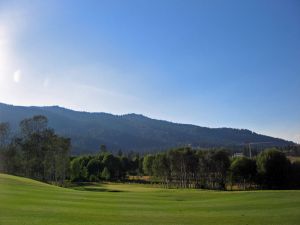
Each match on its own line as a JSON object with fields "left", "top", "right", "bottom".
{"left": 0, "top": 174, "right": 300, "bottom": 225}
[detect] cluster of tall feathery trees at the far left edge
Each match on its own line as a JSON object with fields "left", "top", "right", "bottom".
{"left": 0, "top": 116, "right": 71, "bottom": 184}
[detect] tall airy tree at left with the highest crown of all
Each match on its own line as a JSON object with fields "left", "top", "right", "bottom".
{"left": 19, "top": 115, "right": 71, "bottom": 184}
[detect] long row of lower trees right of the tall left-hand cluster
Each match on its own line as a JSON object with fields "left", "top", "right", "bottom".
{"left": 70, "top": 148, "right": 300, "bottom": 190}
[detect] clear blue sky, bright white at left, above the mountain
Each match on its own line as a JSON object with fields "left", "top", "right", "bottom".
{"left": 0, "top": 0, "right": 300, "bottom": 143}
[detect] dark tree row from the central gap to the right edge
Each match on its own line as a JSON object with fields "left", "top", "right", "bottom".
{"left": 143, "top": 148, "right": 300, "bottom": 190}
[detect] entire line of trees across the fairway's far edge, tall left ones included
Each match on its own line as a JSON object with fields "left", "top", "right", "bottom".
{"left": 0, "top": 116, "right": 300, "bottom": 190}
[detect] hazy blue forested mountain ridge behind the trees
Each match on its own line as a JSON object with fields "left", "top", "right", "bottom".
{"left": 0, "top": 103, "right": 294, "bottom": 153}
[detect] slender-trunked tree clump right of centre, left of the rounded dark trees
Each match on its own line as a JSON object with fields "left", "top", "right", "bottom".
{"left": 143, "top": 148, "right": 230, "bottom": 189}
